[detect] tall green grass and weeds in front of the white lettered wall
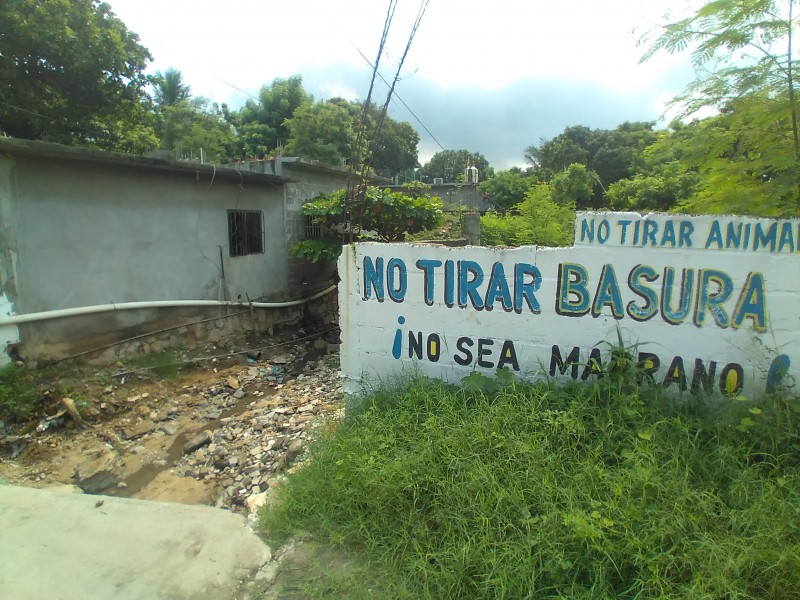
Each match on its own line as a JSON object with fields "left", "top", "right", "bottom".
{"left": 260, "top": 377, "right": 800, "bottom": 599}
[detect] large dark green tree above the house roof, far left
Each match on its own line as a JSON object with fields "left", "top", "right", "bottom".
{"left": 0, "top": 0, "right": 156, "bottom": 152}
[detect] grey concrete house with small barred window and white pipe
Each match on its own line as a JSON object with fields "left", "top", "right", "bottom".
{"left": 0, "top": 138, "right": 347, "bottom": 362}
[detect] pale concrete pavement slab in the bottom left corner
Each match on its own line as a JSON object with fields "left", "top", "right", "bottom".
{"left": 0, "top": 485, "right": 270, "bottom": 600}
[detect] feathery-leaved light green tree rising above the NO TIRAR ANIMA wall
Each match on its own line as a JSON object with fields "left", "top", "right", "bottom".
{"left": 642, "top": 0, "right": 800, "bottom": 212}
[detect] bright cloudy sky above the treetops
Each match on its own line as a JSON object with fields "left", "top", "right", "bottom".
{"left": 107, "top": 0, "right": 696, "bottom": 170}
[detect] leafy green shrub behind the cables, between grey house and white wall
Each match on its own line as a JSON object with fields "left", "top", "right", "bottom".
{"left": 291, "top": 182, "right": 443, "bottom": 262}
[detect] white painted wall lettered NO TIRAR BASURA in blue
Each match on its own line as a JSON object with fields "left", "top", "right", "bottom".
{"left": 339, "top": 213, "right": 800, "bottom": 397}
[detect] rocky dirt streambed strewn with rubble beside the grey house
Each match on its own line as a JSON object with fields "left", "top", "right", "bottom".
{"left": 0, "top": 338, "right": 342, "bottom": 512}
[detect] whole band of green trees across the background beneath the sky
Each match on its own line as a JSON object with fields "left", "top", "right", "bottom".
{"left": 0, "top": 0, "right": 800, "bottom": 218}
